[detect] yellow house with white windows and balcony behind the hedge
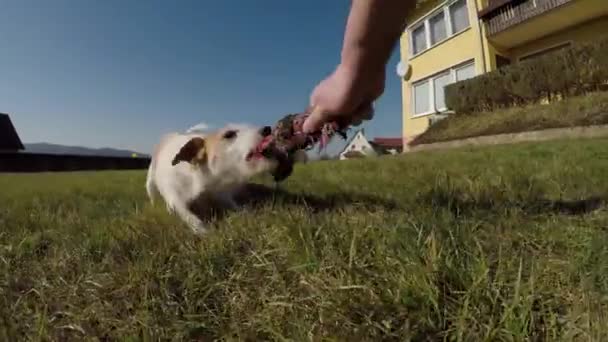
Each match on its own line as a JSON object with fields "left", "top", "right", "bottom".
{"left": 397, "top": 0, "right": 608, "bottom": 146}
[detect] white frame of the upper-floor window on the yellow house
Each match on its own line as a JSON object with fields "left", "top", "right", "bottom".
{"left": 407, "top": 0, "right": 471, "bottom": 59}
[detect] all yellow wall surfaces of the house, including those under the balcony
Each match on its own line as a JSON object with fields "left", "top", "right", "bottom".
{"left": 400, "top": 0, "right": 608, "bottom": 146}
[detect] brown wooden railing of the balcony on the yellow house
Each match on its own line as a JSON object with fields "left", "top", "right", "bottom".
{"left": 480, "top": 0, "right": 574, "bottom": 36}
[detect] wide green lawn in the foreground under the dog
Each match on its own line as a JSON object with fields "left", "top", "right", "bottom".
{"left": 0, "top": 139, "right": 608, "bottom": 341}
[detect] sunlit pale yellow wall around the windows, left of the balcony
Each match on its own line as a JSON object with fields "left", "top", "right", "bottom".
{"left": 400, "top": 0, "right": 486, "bottom": 140}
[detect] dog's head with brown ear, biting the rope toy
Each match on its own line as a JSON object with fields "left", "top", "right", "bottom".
{"left": 172, "top": 125, "right": 277, "bottom": 183}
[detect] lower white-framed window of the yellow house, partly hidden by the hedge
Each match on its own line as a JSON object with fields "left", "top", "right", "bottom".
{"left": 412, "top": 62, "right": 475, "bottom": 117}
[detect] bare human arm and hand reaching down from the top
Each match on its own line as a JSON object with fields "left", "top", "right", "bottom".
{"left": 304, "top": 0, "right": 416, "bottom": 132}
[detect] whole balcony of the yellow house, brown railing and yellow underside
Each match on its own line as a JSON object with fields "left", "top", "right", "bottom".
{"left": 479, "top": 0, "right": 608, "bottom": 48}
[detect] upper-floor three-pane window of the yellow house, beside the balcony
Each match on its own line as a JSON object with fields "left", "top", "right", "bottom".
{"left": 409, "top": 0, "right": 470, "bottom": 56}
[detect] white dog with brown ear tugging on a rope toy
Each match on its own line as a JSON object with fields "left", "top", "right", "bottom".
{"left": 146, "top": 125, "right": 277, "bottom": 233}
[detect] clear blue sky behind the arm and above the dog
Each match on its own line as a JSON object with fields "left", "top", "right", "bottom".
{"left": 0, "top": 0, "right": 401, "bottom": 153}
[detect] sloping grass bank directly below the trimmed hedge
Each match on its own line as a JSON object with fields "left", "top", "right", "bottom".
{"left": 411, "top": 92, "right": 608, "bottom": 146}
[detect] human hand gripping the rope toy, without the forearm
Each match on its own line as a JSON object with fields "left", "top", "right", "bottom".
{"left": 303, "top": 64, "right": 386, "bottom": 133}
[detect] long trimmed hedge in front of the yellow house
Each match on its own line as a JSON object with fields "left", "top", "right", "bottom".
{"left": 445, "top": 39, "right": 608, "bottom": 114}
